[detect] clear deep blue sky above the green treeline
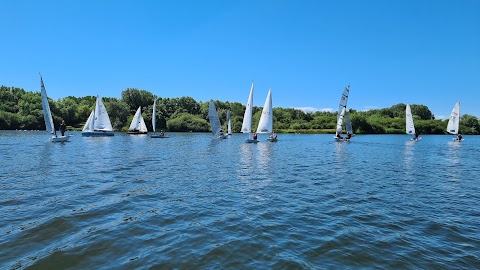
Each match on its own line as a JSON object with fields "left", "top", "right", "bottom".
{"left": 0, "top": 0, "right": 480, "bottom": 117}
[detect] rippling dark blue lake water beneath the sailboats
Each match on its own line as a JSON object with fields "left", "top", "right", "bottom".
{"left": 0, "top": 131, "right": 480, "bottom": 269}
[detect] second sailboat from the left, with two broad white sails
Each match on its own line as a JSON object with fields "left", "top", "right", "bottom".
{"left": 82, "top": 96, "right": 114, "bottom": 137}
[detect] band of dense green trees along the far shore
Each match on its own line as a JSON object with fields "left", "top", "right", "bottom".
{"left": 0, "top": 86, "right": 480, "bottom": 134}
